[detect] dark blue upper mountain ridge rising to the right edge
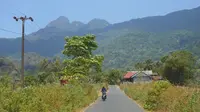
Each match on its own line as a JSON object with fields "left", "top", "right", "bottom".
{"left": 107, "top": 7, "right": 200, "bottom": 32}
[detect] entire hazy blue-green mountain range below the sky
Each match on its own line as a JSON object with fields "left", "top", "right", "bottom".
{"left": 0, "top": 7, "right": 200, "bottom": 68}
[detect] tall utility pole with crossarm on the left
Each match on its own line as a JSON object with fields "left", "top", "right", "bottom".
{"left": 13, "top": 16, "right": 33, "bottom": 88}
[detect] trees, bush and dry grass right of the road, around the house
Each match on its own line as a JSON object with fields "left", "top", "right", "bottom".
{"left": 120, "top": 51, "right": 200, "bottom": 112}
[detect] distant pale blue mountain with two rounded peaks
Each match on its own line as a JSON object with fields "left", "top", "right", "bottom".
{"left": 26, "top": 16, "right": 110, "bottom": 41}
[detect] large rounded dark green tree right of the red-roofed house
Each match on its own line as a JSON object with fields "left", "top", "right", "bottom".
{"left": 162, "top": 51, "right": 195, "bottom": 84}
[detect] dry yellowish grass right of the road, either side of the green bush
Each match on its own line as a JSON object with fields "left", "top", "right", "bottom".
{"left": 120, "top": 83, "right": 200, "bottom": 112}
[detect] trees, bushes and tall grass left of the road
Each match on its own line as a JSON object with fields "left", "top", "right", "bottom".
{"left": 0, "top": 35, "right": 111, "bottom": 112}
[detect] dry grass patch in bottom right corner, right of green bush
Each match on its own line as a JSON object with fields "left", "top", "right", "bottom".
{"left": 158, "top": 86, "right": 200, "bottom": 112}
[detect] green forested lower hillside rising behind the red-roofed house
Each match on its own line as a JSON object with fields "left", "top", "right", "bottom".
{"left": 96, "top": 30, "right": 200, "bottom": 69}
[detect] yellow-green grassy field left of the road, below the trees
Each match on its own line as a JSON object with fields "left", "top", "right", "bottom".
{"left": 0, "top": 79, "right": 102, "bottom": 112}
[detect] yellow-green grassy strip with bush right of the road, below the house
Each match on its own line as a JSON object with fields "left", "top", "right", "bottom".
{"left": 120, "top": 81, "right": 200, "bottom": 112}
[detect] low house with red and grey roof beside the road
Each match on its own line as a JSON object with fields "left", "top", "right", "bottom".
{"left": 123, "top": 71, "right": 158, "bottom": 83}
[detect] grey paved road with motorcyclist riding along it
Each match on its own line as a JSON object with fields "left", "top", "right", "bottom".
{"left": 85, "top": 86, "right": 144, "bottom": 112}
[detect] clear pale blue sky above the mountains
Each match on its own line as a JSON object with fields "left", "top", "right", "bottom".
{"left": 0, "top": 0, "right": 200, "bottom": 38}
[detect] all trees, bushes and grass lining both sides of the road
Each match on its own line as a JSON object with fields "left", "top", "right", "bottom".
{"left": 0, "top": 35, "right": 200, "bottom": 112}
